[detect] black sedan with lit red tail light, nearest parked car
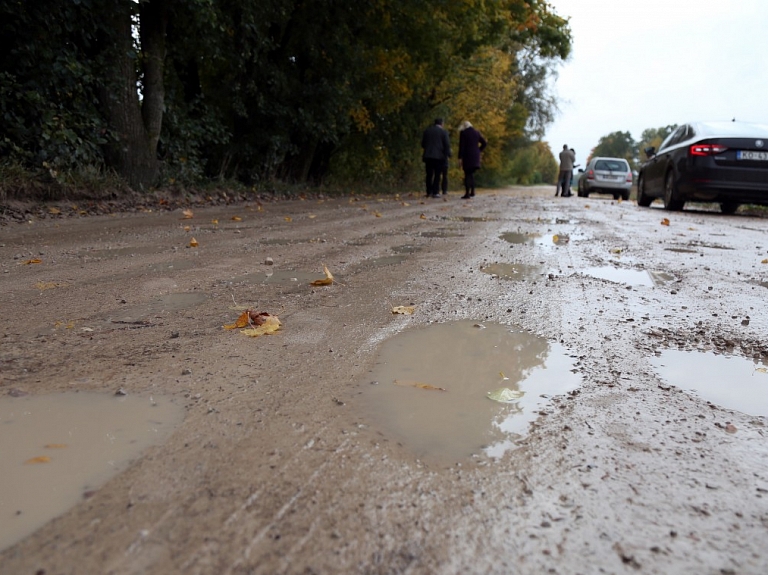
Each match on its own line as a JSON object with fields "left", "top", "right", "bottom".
{"left": 637, "top": 122, "right": 768, "bottom": 214}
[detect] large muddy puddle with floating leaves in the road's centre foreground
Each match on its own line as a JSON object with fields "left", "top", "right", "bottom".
{"left": 361, "top": 321, "right": 580, "bottom": 464}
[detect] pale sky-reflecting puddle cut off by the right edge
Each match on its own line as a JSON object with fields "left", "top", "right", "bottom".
{"left": 651, "top": 350, "right": 768, "bottom": 417}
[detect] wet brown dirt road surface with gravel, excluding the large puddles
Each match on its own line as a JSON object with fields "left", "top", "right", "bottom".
{"left": 0, "top": 188, "right": 768, "bottom": 575}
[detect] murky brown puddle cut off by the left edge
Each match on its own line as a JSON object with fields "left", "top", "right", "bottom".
{"left": 0, "top": 392, "right": 183, "bottom": 550}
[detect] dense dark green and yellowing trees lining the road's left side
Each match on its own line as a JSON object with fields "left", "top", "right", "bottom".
{"left": 0, "top": 0, "right": 571, "bottom": 202}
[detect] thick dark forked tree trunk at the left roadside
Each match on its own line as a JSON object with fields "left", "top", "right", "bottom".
{"left": 101, "top": 0, "right": 166, "bottom": 189}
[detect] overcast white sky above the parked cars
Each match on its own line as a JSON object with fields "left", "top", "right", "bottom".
{"left": 545, "top": 0, "right": 768, "bottom": 166}
